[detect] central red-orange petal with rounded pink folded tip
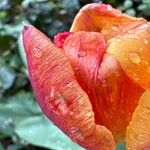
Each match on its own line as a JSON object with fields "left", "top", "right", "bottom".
{"left": 63, "top": 31, "right": 143, "bottom": 141}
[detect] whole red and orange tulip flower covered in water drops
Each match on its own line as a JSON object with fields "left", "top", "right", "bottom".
{"left": 23, "top": 3, "right": 150, "bottom": 150}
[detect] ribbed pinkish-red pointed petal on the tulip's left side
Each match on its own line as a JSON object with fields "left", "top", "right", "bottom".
{"left": 23, "top": 26, "right": 115, "bottom": 150}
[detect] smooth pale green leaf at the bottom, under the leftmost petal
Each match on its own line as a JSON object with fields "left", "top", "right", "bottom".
{"left": 15, "top": 115, "right": 83, "bottom": 150}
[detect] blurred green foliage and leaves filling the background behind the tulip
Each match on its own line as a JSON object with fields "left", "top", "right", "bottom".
{"left": 0, "top": 0, "right": 150, "bottom": 150}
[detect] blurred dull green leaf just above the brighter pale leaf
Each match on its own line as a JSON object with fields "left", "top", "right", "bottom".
{"left": 0, "top": 92, "right": 41, "bottom": 121}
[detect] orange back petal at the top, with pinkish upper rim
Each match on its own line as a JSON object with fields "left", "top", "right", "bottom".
{"left": 70, "top": 3, "right": 146, "bottom": 40}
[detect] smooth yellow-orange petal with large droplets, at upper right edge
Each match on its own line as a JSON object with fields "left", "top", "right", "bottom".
{"left": 107, "top": 24, "right": 150, "bottom": 89}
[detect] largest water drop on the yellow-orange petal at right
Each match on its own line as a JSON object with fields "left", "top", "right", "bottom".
{"left": 129, "top": 52, "right": 141, "bottom": 64}
